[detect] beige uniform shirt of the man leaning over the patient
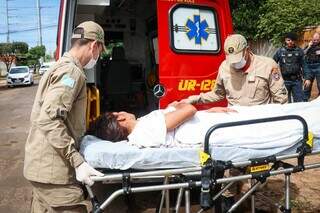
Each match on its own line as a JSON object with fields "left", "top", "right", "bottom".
{"left": 187, "top": 53, "right": 288, "bottom": 106}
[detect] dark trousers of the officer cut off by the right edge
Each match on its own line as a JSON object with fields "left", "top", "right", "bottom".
{"left": 303, "top": 63, "right": 320, "bottom": 101}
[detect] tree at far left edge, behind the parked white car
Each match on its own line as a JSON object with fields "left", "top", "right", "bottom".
{"left": 0, "top": 42, "right": 28, "bottom": 71}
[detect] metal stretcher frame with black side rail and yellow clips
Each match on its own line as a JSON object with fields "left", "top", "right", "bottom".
{"left": 86, "top": 115, "right": 320, "bottom": 213}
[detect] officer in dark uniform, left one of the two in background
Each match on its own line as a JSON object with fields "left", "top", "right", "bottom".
{"left": 273, "top": 32, "right": 304, "bottom": 103}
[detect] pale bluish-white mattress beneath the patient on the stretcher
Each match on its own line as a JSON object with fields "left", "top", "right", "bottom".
{"left": 80, "top": 135, "right": 320, "bottom": 170}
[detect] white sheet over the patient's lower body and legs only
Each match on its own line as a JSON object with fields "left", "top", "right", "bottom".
{"left": 174, "top": 98, "right": 320, "bottom": 149}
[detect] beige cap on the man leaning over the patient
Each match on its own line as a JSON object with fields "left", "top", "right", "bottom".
{"left": 224, "top": 34, "right": 248, "bottom": 64}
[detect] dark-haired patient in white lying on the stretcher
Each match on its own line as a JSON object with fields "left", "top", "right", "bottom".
{"left": 89, "top": 97, "right": 320, "bottom": 149}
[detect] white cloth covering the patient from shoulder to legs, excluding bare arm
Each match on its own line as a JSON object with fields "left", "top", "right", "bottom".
{"left": 128, "top": 98, "right": 320, "bottom": 149}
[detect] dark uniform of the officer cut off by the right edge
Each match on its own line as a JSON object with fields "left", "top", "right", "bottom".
{"left": 304, "top": 43, "right": 320, "bottom": 101}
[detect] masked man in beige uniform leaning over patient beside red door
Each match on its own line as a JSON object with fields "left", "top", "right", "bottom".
{"left": 181, "top": 34, "right": 287, "bottom": 106}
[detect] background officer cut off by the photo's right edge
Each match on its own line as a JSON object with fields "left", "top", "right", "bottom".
{"left": 304, "top": 32, "right": 320, "bottom": 101}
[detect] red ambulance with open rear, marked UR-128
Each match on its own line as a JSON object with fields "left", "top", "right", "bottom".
{"left": 56, "top": 0, "right": 232, "bottom": 119}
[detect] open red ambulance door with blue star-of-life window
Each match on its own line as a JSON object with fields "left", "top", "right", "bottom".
{"left": 154, "top": 0, "right": 232, "bottom": 108}
